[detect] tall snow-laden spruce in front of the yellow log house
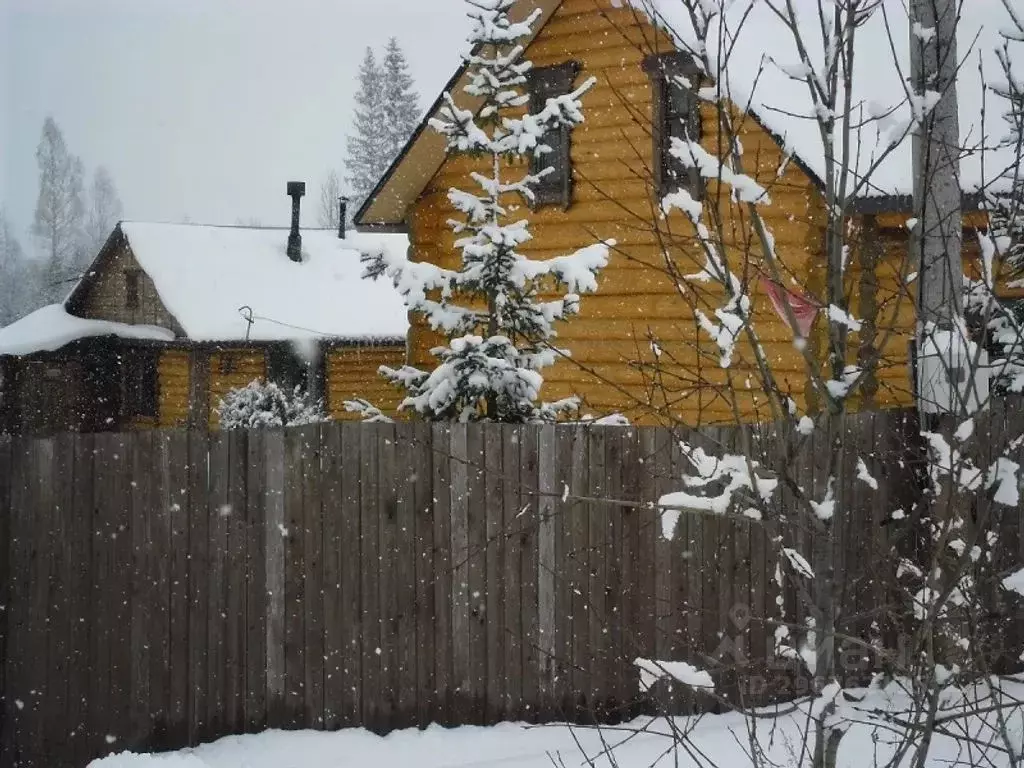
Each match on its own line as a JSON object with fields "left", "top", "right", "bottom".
{"left": 347, "top": 0, "right": 614, "bottom": 423}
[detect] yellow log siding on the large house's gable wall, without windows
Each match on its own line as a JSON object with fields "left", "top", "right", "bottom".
{"left": 410, "top": 0, "right": 847, "bottom": 423}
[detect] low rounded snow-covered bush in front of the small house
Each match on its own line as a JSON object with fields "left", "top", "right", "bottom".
{"left": 217, "top": 379, "right": 330, "bottom": 429}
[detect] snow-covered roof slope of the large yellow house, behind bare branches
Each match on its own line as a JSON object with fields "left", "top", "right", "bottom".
{"left": 616, "top": 0, "right": 1024, "bottom": 197}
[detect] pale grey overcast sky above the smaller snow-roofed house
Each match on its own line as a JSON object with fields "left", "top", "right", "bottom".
{"left": 0, "top": 0, "right": 467, "bottom": 246}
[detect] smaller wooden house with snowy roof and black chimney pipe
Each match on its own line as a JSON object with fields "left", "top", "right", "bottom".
{"left": 0, "top": 221, "right": 408, "bottom": 433}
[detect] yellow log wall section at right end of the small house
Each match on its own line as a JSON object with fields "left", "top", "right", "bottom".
{"left": 325, "top": 347, "right": 406, "bottom": 421}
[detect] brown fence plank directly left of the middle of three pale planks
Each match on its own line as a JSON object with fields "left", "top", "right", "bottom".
{"left": 430, "top": 424, "right": 456, "bottom": 725}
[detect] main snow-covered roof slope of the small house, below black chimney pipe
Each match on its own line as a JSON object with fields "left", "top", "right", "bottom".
{"left": 114, "top": 221, "right": 409, "bottom": 341}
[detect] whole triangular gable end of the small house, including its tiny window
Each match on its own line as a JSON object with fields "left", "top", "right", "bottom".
{"left": 66, "top": 224, "right": 185, "bottom": 337}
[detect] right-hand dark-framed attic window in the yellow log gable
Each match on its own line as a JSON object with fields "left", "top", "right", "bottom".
{"left": 643, "top": 51, "right": 703, "bottom": 200}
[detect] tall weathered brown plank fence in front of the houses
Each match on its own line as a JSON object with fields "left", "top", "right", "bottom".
{"left": 0, "top": 413, "right": 1019, "bottom": 768}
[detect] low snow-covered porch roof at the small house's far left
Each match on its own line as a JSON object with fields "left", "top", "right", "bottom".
{"left": 0, "top": 304, "right": 174, "bottom": 355}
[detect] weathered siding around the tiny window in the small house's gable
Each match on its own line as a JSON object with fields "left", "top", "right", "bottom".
{"left": 75, "top": 240, "right": 180, "bottom": 334}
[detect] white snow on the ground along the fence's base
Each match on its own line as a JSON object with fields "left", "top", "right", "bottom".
{"left": 90, "top": 680, "right": 1024, "bottom": 768}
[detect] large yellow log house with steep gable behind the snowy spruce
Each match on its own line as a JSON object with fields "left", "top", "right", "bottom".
{"left": 356, "top": 0, "right": 1019, "bottom": 423}
